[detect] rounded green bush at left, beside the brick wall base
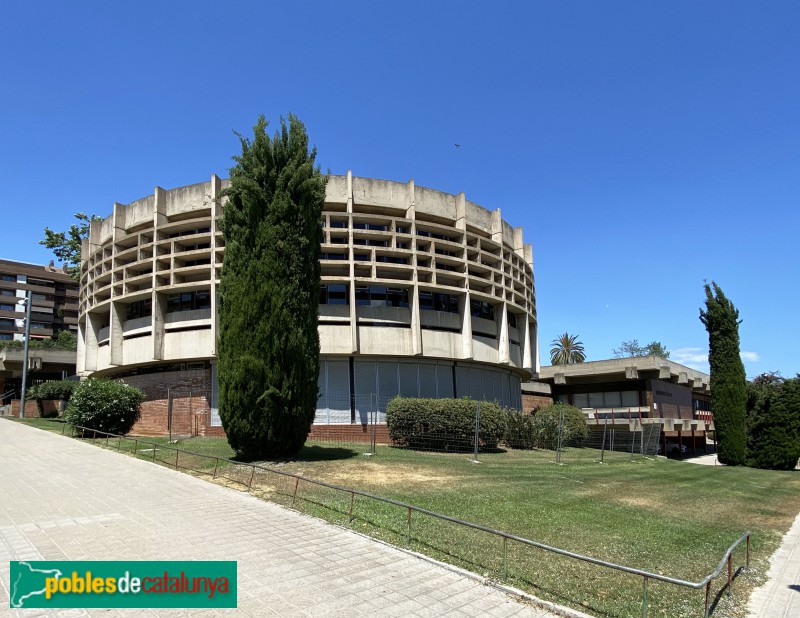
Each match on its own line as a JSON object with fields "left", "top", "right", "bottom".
{"left": 64, "top": 379, "right": 144, "bottom": 435}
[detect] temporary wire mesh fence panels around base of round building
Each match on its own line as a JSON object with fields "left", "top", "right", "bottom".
{"left": 126, "top": 385, "right": 662, "bottom": 464}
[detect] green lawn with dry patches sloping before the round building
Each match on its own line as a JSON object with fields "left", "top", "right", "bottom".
{"left": 7, "top": 419, "right": 800, "bottom": 617}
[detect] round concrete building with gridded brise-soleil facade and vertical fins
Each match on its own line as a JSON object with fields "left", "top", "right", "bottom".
{"left": 78, "top": 173, "right": 538, "bottom": 426}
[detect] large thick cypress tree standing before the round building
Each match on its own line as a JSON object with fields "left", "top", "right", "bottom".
{"left": 217, "top": 115, "right": 326, "bottom": 460}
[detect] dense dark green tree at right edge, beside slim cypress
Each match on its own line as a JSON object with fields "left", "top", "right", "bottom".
{"left": 747, "top": 373, "right": 800, "bottom": 470}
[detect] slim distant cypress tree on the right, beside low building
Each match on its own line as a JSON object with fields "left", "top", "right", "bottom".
{"left": 700, "top": 281, "right": 747, "bottom": 466}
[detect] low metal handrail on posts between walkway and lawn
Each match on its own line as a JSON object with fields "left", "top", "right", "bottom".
{"left": 62, "top": 423, "right": 751, "bottom": 618}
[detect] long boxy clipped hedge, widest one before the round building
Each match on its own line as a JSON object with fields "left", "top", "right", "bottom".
{"left": 386, "top": 397, "right": 506, "bottom": 451}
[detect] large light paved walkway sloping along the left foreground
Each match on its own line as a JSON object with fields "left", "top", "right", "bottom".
{"left": 0, "top": 419, "right": 555, "bottom": 618}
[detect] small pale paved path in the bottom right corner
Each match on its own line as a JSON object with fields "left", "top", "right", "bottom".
{"left": 748, "top": 515, "right": 800, "bottom": 618}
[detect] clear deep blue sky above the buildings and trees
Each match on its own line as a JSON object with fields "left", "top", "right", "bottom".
{"left": 0, "top": 0, "right": 800, "bottom": 376}
